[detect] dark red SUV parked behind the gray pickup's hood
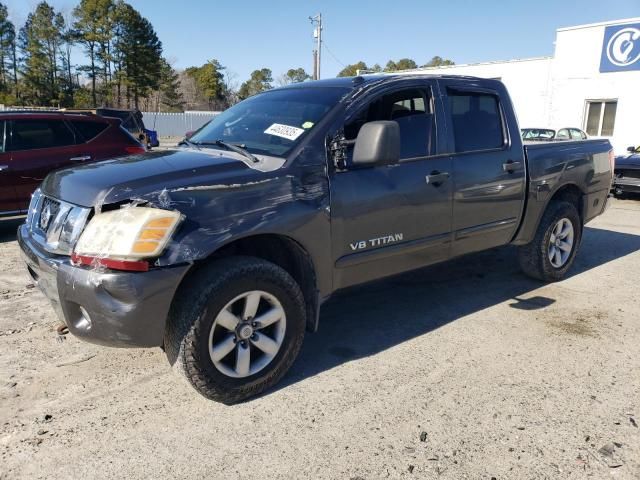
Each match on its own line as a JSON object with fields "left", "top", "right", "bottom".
{"left": 0, "top": 112, "right": 145, "bottom": 216}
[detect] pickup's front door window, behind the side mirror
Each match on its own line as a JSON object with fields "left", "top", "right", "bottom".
{"left": 344, "top": 88, "right": 435, "bottom": 159}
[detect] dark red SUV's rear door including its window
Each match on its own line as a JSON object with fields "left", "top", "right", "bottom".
{"left": 7, "top": 118, "right": 78, "bottom": 210}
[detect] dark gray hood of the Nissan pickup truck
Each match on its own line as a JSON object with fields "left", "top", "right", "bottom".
{"left": 41, "top": 147, "right": 284, "bottom": 207}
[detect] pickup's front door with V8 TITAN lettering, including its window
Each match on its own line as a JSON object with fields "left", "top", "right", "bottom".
{"left": 330, "top": 80, "right": 453, "bottom": 289}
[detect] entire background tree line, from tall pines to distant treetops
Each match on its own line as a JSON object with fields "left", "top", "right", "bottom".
{"left": 0, "top": 0, "right": 453, "bottom": 111}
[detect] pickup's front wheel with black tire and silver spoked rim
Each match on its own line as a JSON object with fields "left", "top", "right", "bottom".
{"left": 164, "top": 256, "right": 306, "bottom": 405}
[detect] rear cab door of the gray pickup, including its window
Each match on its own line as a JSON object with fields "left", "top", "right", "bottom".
{"left": 442, "top": 80, "right": 526, "bottom": 255}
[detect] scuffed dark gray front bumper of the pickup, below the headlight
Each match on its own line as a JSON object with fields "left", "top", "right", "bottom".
{"left": 18, "top": 225, "right": 189, "bottom": 347}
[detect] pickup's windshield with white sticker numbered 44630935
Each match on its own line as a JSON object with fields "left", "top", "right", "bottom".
{"left": 189, "top": 87, "right": 350, "bottom": 156}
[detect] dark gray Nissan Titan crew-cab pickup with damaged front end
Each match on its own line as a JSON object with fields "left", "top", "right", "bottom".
{"left": 18, "top": 76, "right": 613, "bottom": 403}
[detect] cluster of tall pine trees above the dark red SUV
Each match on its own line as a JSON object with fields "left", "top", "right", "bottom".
{"left": 0, "top": 0, "right": 170, "bottom": 108}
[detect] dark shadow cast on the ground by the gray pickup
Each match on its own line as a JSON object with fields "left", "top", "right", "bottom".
{"left": 275, "top": 227, "right": 640, "bottom": 396}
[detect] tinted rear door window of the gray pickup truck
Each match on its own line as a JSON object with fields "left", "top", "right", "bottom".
{"left": 449, "top": 91, "right": 504, "bottom": 153}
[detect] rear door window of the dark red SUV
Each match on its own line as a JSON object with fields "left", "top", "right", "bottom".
{"left": 8, "top": 120, "right": 75, "bottom": 151}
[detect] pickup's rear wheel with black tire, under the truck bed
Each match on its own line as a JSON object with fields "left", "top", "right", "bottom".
{"left": 518, "top": 201, "right": 582, "bottom": 282}
